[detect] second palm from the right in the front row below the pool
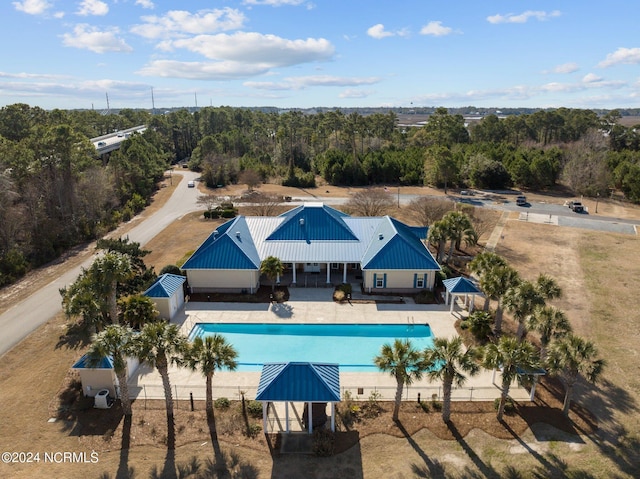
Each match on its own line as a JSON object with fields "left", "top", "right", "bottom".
{"left": 483, "top": 336, "right": 538, "bottom": 421}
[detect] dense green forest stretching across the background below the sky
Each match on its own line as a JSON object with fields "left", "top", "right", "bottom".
{"left": 0, "top": 104, "right": 640, "bottom": 285}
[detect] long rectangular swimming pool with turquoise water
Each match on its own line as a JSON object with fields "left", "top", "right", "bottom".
{"left": 189, "top": 323, "right": 433, "bottom": 372}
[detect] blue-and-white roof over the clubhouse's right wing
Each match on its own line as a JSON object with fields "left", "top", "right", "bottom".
{"left": 362, "top": 216, "right": 440, "bottom": 270}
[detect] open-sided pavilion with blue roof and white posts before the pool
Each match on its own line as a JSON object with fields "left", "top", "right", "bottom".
{"left": 256, "top": 362, "right": 340, "bottom": 434}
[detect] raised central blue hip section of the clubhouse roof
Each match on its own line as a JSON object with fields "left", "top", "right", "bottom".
{"left": 266, "top": 203, "right": 358, "bottom": 243}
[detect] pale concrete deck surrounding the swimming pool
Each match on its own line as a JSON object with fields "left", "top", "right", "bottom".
{"left": 129, "top": 288, "right": 529, "bottom": 401}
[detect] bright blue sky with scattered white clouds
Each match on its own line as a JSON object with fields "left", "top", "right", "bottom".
{"left": 0, "top": 0, "right": 640, "bottom": 110}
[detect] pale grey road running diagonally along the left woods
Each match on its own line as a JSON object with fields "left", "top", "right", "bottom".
{"left": 0, "top": 170, "right": 202, "bottom": 356}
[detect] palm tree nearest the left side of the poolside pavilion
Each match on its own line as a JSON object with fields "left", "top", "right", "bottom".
{"left": 186, "top": 334, "right": 238, "bottom": 419}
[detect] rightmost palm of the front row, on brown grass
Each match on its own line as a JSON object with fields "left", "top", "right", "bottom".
{"left": 546, "top": 334, "right": 606, "bottom": 416}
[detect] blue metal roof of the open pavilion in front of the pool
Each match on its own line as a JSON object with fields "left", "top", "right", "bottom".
{"left": 256, "top": 363, "right": 340, "bottom": 402}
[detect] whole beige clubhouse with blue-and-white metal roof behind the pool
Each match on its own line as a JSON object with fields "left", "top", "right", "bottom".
{"left": 182, "top": 203, "right": 440, "bottom": 293}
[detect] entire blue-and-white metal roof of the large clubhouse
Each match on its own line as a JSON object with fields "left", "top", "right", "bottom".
{"left": 182, "top": 203, "right": 440, "bottom": 271}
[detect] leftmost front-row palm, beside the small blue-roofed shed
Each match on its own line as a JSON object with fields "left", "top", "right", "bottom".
{"left": 87, "top": 324, "right": 133, "bottom": 416}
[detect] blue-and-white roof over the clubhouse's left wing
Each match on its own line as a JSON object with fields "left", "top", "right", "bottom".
{"left": 182, "top": 216, "right": 260, "bottom": 270}
